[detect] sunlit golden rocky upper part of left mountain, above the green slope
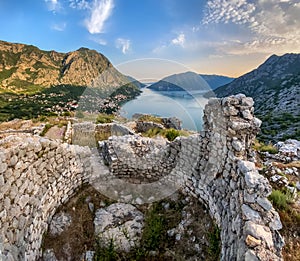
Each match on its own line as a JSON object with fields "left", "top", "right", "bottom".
{"left": 0, "top": 41, "right": 129, "bottom": 93}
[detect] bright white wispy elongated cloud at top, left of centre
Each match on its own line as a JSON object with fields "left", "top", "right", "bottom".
{"left": 85, "top": 0, "right": 114, "bottom": 34}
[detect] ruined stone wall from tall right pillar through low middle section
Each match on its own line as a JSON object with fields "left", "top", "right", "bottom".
{"left": 102, "top": 95, "right": 283, "bottom": 260}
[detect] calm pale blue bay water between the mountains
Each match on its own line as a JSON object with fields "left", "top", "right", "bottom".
{"left": 120, "top": 88, "right": 207, "bottom": 131}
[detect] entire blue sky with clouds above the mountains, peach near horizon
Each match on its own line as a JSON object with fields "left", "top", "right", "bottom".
{"left": 0, "top": 0, "right": 300, "bottom": 80}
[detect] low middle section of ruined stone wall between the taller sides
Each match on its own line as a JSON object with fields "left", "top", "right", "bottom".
{"left": 99, "top": 135, "right": 178, "bottom": 183}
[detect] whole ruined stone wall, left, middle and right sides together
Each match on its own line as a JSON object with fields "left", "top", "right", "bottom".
{"left": 0, "top": 95, "right": 283, "bottom": 260}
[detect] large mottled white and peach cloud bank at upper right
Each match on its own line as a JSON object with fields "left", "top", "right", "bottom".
{"left": 202, "top": 0, "right": 300, "bottom": 54}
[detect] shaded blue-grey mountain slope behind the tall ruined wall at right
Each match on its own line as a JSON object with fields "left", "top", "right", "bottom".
{"left": 215, "top": 54, "right": 300, "bottom": 140}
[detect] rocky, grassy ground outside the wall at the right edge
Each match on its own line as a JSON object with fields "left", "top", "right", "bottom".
{"left": 257, "top": 140, "right": 300, "bottom": 261}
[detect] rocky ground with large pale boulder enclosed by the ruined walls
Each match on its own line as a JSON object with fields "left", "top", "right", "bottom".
{"left": 42, "top": 186, "right": 220, "bottom": 261}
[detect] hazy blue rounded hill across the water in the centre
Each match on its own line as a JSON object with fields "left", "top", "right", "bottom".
{"left": 148, "top": 72, "right": 210, "bottom": 91}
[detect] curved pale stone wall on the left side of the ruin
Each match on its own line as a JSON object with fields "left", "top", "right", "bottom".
{"left": 0, "top": 135, "right": 90, "bottom": 260}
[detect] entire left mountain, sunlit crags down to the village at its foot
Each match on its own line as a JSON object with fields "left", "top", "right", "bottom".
{"left": 0, "top": 41, "right": 141, "bottom": 121}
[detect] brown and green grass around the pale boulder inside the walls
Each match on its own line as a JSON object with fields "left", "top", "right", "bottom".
{"left": 42, "top": 186, "right": 220, "bottom": 261}
